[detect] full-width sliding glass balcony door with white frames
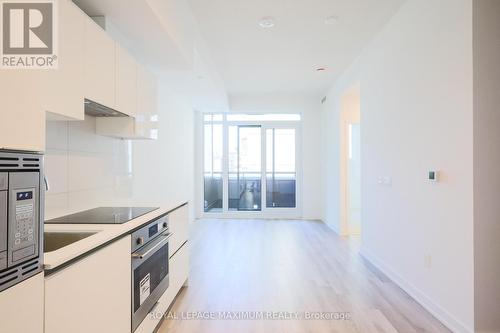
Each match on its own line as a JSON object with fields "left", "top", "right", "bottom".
{"left": 204, "top": 115, "right": 300, "bottom": 217}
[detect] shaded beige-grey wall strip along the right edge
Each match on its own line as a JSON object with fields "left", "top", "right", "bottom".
{"left": 474, "top": 0, "right": 500, "bottom": 332}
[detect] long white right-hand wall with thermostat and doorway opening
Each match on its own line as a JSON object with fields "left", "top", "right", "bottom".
{"left": 322, "top": 0, "right": 474, "bottom": 332}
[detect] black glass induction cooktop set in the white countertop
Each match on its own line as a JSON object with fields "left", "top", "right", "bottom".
{"left": 45, "top": 207, "right": 159, "bottom": 224}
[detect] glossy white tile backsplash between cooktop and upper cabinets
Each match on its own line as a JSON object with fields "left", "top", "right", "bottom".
{"left": 45, "top": 116, "right": 133, "bottom": 219}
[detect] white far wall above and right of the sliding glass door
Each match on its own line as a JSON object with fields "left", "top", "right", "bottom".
{"left": 225, "top": 94, "right": 322, "bottom": 219}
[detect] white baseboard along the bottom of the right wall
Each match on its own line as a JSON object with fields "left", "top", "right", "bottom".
{"left": 360, "top": 247, "right": 474, "bottom": 333}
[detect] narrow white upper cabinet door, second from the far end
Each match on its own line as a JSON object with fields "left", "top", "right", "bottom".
{"left": 115, "top": 43, "right": 137, "bottom": 116}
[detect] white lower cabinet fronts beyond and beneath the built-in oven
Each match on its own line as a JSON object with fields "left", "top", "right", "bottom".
{"left": 135, "top": 241, "right": 189, "bottom": 333}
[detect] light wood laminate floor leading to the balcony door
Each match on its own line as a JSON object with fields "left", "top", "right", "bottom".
{"left": 158, "top": 219, "right": 450, "bottom": 333}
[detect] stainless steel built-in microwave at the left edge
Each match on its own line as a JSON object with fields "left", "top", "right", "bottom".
{"left": 0, "top": 150, "right": 44, "bottom": 291}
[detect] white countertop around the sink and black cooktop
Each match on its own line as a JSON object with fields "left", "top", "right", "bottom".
{"left": 43, "top": 202, "right": 185, "bottom": 270}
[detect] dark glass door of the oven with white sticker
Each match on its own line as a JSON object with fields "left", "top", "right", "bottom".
{"left": 132, "top": 242, "right": 168, "bottom": 313}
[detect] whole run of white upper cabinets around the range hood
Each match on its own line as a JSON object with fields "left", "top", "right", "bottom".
{"left": 0, "top": 0, "right": 157, "bottom": 151}
